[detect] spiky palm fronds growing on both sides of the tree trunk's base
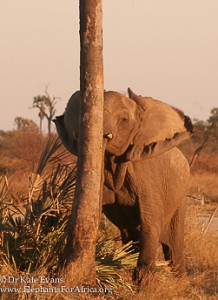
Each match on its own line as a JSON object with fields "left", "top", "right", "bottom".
{"left": 0, "top": 138, "right": 137, "bottom": 299}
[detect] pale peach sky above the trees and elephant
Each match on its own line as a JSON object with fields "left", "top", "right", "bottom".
{"left": 0, "top": 0, "right": 218, "bottom": 130}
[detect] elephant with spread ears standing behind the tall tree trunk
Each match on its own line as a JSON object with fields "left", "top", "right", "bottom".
{"left": 54, "top": 88, "right": 193, "bottom": 283}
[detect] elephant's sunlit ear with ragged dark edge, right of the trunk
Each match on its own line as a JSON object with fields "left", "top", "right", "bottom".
{"left": 117, "top": 89, "right": 193, "bottom": 161}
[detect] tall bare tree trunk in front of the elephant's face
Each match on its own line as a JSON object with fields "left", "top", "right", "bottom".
{"left": 63, "top": 0, "right": 104, "bottom": 283}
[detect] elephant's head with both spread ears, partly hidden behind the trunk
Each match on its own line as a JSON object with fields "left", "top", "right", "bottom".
{"left": 55, "top": 89, "right": 193, "bottom": 162}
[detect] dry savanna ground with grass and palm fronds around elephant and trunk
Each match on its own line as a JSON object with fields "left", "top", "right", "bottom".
{"left": 0, "top": 123, "right": 218, "bottom": 300}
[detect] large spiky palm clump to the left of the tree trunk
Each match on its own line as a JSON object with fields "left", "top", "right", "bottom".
{"left": 0, "top": 138, "right": 76, "bottom": 273}
